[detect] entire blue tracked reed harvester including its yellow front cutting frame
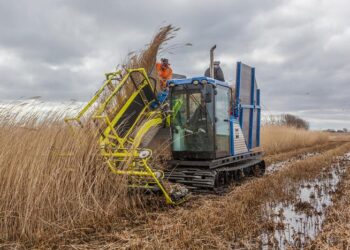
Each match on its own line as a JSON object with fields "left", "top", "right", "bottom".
{"left": 66, "top": 47, "right": 265, "bottom": 204}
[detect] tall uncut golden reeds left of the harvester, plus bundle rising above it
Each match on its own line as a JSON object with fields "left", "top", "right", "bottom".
{"left": 0, "top": 25, "right": 177, "bottom": 245}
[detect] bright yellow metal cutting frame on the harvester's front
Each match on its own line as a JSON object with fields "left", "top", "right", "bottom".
{"left": 65, "top": 68, "right": 178, "bottom": 204}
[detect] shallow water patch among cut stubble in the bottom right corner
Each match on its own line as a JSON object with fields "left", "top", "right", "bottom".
{"left": 261, "top": 153, "right": 350, "bottom": 249}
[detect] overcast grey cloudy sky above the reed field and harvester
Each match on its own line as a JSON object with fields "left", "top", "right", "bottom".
{"left": 0, "top": 0, "right": 350, "bottom": 128}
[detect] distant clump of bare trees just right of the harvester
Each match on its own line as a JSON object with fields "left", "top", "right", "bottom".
{"left": 265, "top": 114, "right": 310, "bottom": 130}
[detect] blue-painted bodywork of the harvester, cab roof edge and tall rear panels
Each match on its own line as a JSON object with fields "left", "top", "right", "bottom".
{"left": 167, "top": 62, "right": 261, "bottom": 156}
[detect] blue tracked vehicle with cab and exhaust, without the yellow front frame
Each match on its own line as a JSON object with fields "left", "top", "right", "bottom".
{"left": 165, "top": 46, "right": 265, "bottom": 192}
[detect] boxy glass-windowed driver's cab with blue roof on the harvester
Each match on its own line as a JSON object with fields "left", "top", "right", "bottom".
{"left": 168, "top": 77, "right": 233, "bottom": 160}
